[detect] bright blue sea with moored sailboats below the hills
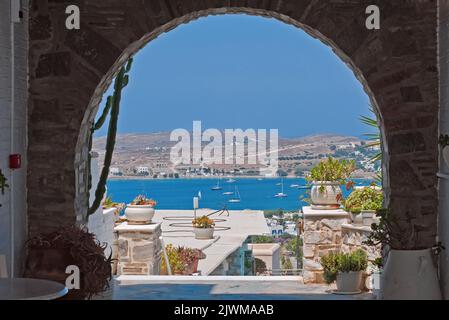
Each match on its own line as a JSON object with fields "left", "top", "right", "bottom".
{"left": 107, "top": 178, "right": 372, "bottom": 211}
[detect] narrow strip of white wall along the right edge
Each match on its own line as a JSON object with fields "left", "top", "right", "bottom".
{"left": 438, "top": 0, "right": 449, "bottom": 299}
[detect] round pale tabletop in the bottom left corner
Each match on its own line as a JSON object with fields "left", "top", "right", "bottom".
{"left": 0, "top": 278, "right": 68, "bottom": 300}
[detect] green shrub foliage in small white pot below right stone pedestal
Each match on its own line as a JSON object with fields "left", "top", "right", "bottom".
{"left": 321, "top": 249, "right": 368, "bottom": 284}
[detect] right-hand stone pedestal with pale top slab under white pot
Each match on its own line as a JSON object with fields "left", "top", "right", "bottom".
{"left": 302, "top": 207, "right": 350, "bottom": 284}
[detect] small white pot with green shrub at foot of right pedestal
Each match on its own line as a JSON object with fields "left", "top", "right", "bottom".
{"left": 321, "top": 249, "right": 368, "bottom": 294}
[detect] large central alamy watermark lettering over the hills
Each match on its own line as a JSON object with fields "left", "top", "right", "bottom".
{"left": 170, "top": 121, "right": 279, "bottom": 175}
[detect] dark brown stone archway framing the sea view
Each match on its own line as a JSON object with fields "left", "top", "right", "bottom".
{"left": 28, "top": 0, "right": 438, "bottom": 247}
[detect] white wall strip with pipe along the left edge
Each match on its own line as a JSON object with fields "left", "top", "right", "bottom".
{"left": 0, "top": 0, "right": 28, "bottom": 276}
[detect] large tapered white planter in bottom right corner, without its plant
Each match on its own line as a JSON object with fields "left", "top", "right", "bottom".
{"left": 380, "top": 249, "right": 442, "bottom": 300}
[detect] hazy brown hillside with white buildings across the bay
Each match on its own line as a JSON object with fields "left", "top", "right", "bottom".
{"left": 93, "top": 132, "right": 376, "bottom": 176}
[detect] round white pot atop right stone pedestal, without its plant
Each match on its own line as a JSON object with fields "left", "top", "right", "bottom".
{"left": 310, "top": 181, "right": 342, "bottom": 210}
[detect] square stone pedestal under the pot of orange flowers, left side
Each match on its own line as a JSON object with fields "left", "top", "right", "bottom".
{"left": 114, "top": 222, "right": 162, "bottom": 275}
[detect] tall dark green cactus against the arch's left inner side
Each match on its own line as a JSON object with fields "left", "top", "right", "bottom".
{"left": 87, "top": 59, "right": 132, "bottom": 216}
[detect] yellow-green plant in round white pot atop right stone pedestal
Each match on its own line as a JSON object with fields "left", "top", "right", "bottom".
{"left": 306, "top": 157, "right": 355, "bottom": 210}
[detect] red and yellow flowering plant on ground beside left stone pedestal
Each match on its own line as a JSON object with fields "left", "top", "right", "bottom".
{"left": 161, "top": 244, "right": 205, "bottom": 275}
